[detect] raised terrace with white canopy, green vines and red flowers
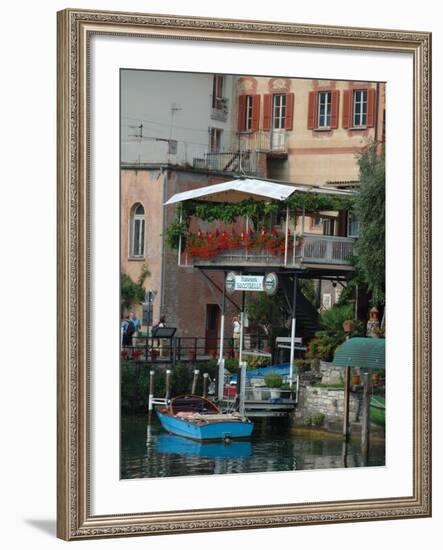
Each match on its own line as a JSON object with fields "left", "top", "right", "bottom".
{"left": 165, "top": 178, "right": 356, "bottom": 274}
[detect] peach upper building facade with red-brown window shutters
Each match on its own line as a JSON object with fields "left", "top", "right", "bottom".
{"left": 224, "top": 76, "right": 385, "bottom": 185}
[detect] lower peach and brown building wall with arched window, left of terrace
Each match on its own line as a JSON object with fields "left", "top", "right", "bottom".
{"left": 121, "top": 164, "right": 239, "bottom": 337}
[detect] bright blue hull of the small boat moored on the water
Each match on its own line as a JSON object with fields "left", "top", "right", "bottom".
{"left": 156, "top": 411, "right": 254, "bottom": 441}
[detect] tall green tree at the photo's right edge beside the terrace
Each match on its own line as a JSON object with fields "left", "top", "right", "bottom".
{"left": 354, "top": 143, "right": 385, "bottom": 305}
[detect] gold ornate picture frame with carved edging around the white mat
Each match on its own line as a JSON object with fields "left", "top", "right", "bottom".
{"left": 57, "top": 9, "right": 431, "bottom": 540}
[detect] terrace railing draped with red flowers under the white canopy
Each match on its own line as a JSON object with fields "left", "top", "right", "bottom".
{"left": 181, "top": 233, "right": 355, "bottom": 267}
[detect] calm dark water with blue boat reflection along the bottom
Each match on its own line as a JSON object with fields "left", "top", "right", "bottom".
{"left": 121, "top": 415, "right": 385, "bottom": 479}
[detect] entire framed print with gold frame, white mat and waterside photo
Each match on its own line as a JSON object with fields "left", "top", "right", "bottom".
{"left": 58, "top": 9, "right": 431, "bottom": 540}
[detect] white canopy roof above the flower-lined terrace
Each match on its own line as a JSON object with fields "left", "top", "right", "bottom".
{"left": 165, "top": 178, "right": 353, "bottom": 205}
